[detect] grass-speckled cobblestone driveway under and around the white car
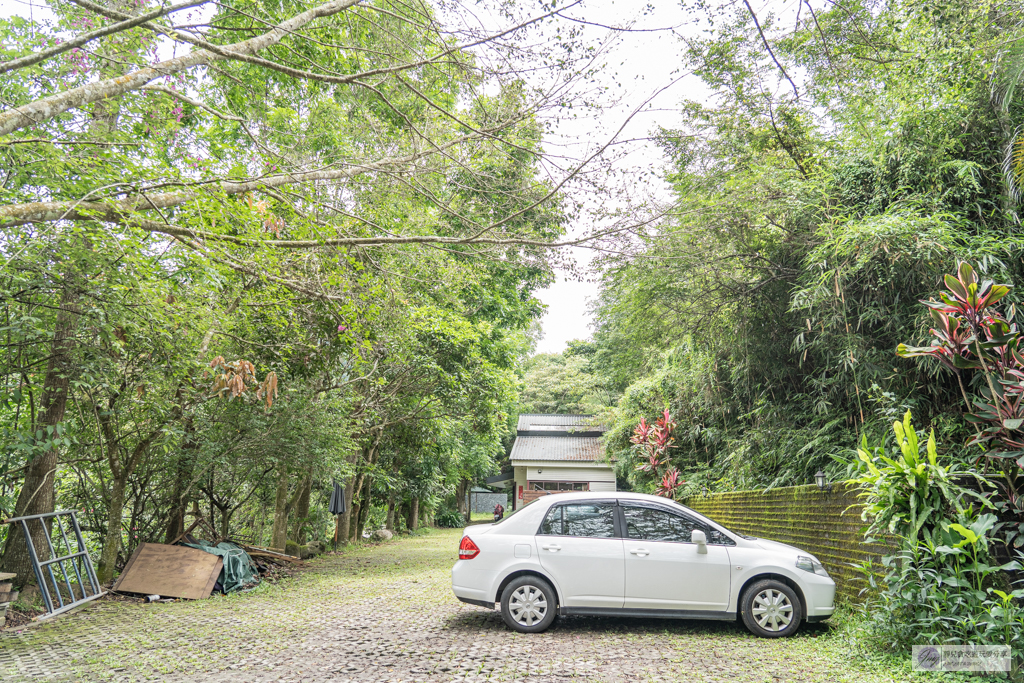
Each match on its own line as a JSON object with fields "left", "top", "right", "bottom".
{"left": 0, "top": 531, "right": 913, "bottom": 683}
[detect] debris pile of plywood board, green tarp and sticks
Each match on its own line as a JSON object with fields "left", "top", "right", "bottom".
{"left": 112, "top": 517, "right": 302, "bottom": 601}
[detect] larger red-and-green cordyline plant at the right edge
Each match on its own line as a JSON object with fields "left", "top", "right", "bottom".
{"left": 896, "top": 263, "right": 1024, "bottom": 469}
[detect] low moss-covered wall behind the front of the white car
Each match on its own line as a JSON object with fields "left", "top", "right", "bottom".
{"left": 684, "top": 481, "right": 889, "bottom": 601}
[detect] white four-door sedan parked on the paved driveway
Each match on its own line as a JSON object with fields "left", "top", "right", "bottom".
{"left": 452, "top": 493, "right": 836, "bottom": 638}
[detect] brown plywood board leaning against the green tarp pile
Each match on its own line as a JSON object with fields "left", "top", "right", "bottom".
{"left": 114, "top": 543, "right": 224, "bottom": 600}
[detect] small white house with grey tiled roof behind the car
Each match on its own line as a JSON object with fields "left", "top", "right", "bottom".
{"left": 499, "top": 415, "right": 615, "bottom": 509}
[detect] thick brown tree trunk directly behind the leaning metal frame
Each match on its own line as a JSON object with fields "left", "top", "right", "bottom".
{"left": 0, "top": 283, "right": 80, "bottom": 585}
